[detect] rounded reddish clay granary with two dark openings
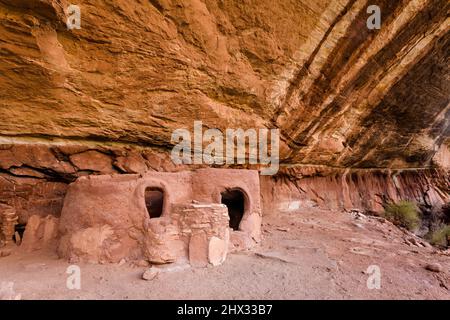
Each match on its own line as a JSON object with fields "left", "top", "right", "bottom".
{"left": 57, "top": 168, "right": 262, "bottom": 267}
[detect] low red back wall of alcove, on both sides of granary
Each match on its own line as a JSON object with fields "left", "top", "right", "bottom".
{"left": 0, "top": 144, "right": 450, "bottom": 223}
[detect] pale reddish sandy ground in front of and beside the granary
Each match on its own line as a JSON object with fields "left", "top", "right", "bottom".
{"left": 0, "top": 210, "right": 450, "bottom": 300}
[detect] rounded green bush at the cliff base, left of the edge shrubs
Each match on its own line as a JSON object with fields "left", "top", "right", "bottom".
{"left": 384, "top": 200, "right": 420, "bottom": 230}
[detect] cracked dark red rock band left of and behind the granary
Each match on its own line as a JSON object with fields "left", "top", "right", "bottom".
{"left": 0, "top": 144, "right": 192, "bottom": 223}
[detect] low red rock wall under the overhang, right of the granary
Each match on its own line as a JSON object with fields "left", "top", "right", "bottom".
{"left": 261, "top": 167, "right": 450, "bottom": 214}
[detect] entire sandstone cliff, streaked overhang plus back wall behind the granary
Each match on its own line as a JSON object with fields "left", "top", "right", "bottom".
{"left": 0, "top": 0, "right": 450, "bottom": 235}
